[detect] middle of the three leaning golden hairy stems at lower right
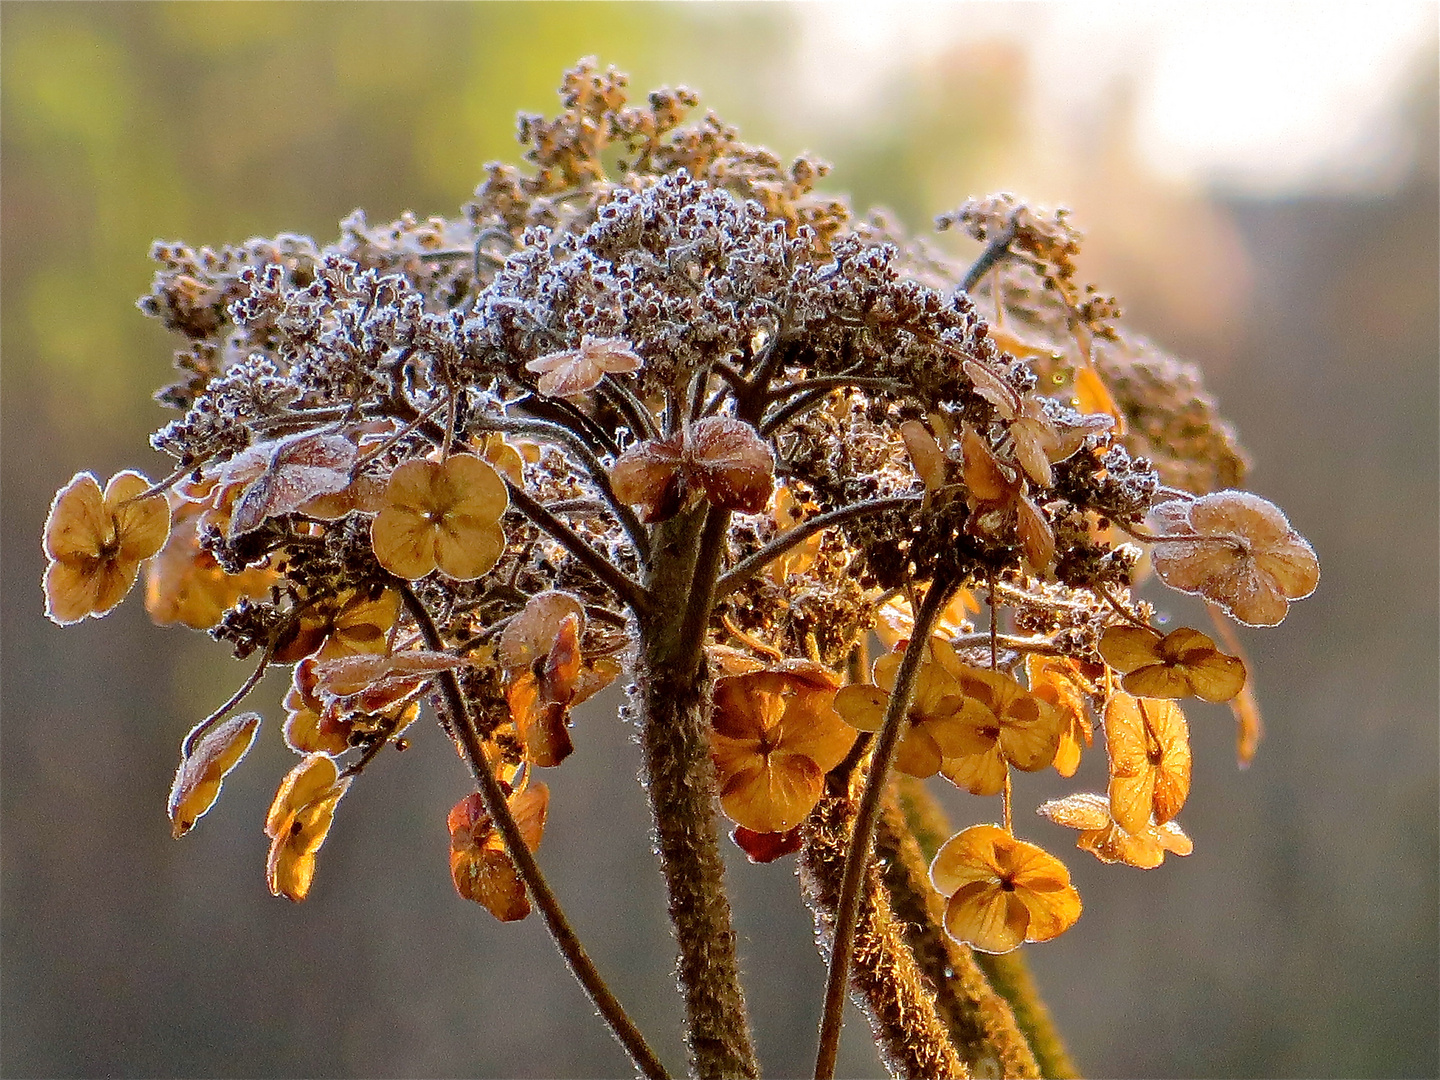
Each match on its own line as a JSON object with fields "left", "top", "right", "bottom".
{"left": 876, "top": 783, "right": 1048, "bottom": 1077}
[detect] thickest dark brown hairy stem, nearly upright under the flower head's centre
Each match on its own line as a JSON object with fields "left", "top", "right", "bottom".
{"left": 634, "top": 511, "right": 759, "bottom": 1077}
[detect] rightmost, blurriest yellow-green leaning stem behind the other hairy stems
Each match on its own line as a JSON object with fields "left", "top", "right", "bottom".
{"left": 900, "top": 779, "right": 1077, "bottom": 1080}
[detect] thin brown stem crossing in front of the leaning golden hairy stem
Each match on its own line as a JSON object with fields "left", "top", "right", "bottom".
{"left": 815, "top": 577, "right": 955, "bottom": 1080}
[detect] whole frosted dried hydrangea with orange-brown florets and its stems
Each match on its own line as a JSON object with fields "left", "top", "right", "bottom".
{"left": 45, "top": 62, "right": 1319, "bottom": 1077}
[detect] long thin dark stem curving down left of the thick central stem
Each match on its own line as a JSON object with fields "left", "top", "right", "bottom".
{"left": 396, "top": 582, "right": 667, "bottom": 1080}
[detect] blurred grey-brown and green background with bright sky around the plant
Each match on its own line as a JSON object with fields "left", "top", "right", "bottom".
{"left": 0, "top": 3, "right": 1440, "bottom": 1077}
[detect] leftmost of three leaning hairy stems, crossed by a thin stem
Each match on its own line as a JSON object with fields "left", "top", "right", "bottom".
{"left": 801, "top": 796, "right": 971, "bottom": 1080}
